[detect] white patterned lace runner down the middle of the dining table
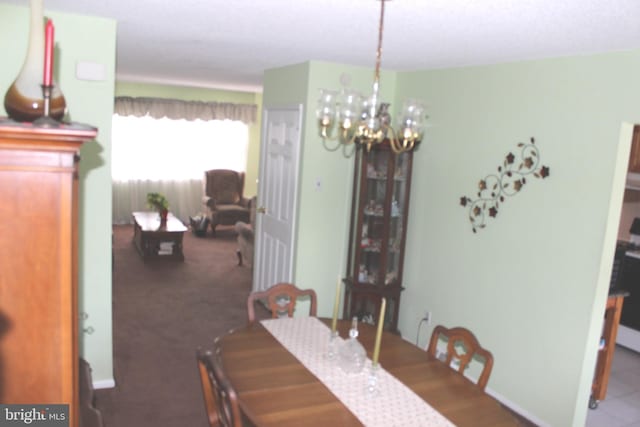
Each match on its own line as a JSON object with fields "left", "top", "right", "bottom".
{"left": 261, "top": 317, "right": 454, "bottom": 427}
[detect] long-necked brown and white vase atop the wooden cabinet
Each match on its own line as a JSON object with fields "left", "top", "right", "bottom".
{"left": 4, "top": 0, "right": 67, "bottom": 122}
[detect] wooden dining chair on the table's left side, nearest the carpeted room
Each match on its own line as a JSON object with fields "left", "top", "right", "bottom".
{"left": 196, "top": 343, "right": 242, "bottom": 427}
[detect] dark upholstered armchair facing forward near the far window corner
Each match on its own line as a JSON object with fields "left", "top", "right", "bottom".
{"left": 202, "top": 169, "right": 250, "bottom": 236}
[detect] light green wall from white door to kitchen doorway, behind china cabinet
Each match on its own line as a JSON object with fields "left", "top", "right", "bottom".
{"left": 264, "top": 51, "right": 640, "bottom": 426}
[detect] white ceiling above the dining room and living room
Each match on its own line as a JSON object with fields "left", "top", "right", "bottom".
{"left": 0, "top": 0, "right": 640, "bottom": 90}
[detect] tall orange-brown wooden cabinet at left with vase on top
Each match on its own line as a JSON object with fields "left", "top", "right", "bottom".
{"left": 0, "top": 118, "right": 97, "bottom": 427}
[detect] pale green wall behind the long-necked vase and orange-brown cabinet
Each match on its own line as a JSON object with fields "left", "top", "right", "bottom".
{"left": 0, "top": 3, "right": 116, "bottom": 386}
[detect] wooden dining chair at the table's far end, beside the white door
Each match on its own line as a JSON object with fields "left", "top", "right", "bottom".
{"left": 247, "top": 282, "right": 317, "bottom": 323}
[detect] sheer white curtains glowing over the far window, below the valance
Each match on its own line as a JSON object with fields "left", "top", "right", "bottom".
{"left": 111, "top": 114, "right": 249, "bottom": 224}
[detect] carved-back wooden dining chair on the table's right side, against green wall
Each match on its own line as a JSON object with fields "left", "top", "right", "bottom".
{"left": 427, "top": 325, "right": 493, "bottom": 390}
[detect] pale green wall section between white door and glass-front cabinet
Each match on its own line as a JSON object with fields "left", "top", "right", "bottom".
{"left": 263, "top": 61, "right": 395, "bottom": 324}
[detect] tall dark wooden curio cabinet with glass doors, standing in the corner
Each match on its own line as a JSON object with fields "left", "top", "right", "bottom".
{"left": 343, "top": 142, "right": 413, "bottom": 332}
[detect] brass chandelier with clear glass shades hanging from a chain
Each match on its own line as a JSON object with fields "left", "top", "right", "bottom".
{"left": 317, "top": 0, "right": 424, "bottom": 154}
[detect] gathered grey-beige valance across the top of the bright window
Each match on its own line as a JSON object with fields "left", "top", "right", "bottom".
{"left": 114, "top": 96, "right": 258, "bottom": 124}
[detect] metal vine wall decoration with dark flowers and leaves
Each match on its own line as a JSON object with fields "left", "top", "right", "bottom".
{"left": 460, "top": 138, "right": 549, "bottom": 233}
